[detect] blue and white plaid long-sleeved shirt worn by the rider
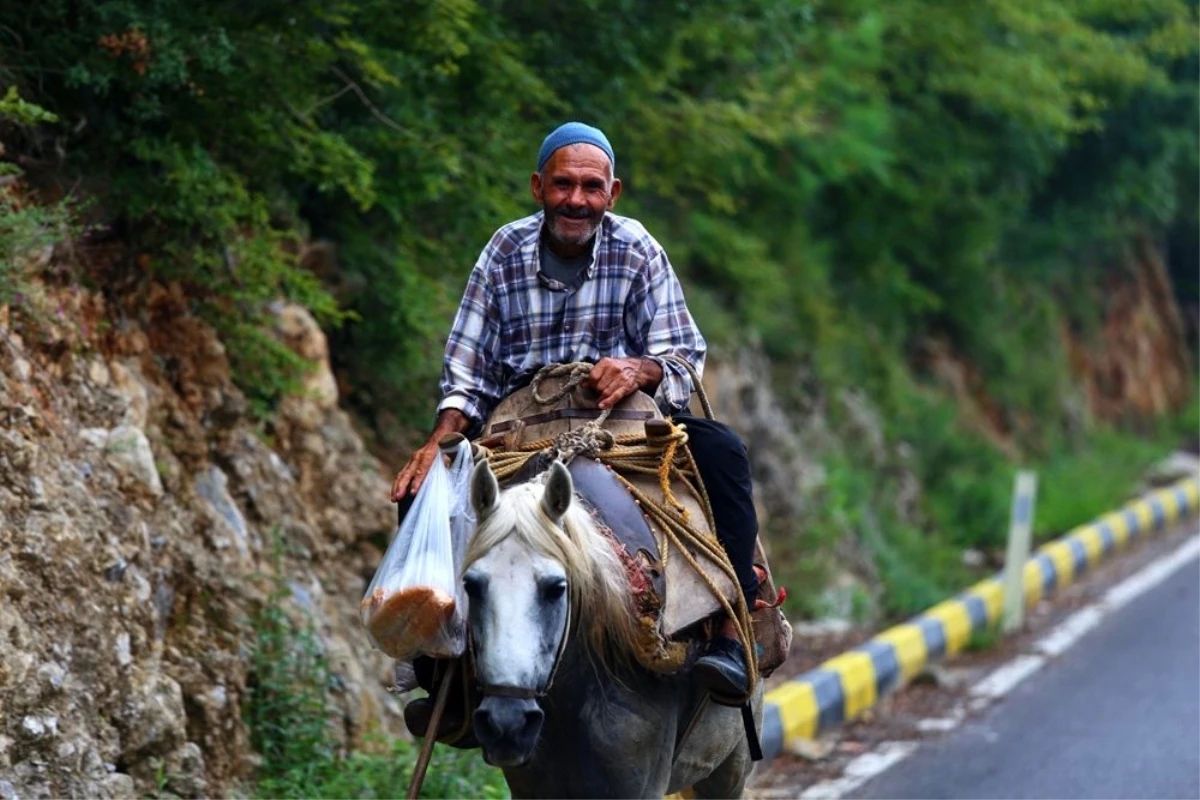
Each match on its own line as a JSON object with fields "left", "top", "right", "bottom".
{"left": 438, "top": 211, "right": 707, "bottom": 421}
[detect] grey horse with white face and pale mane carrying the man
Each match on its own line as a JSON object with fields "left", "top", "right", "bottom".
{"left": 463, "top": 462, "right": 762, "bottom": 800}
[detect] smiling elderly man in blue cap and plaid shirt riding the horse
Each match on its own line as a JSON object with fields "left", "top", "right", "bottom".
{"left": 391, "top": 122, "right": 758, "bottom": 697}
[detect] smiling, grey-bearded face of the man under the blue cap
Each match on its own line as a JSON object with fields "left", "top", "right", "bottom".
{"left": 530, "top": 144, "right": 620, "bottom": 250}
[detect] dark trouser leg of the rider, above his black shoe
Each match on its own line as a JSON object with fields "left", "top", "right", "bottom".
{"left": 673, "top": 411, "right": 758, "bottom": 610}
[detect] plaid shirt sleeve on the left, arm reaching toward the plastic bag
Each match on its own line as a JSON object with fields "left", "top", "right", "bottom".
{"left": 438, "top": 248, "right": 502, "bottom": 422}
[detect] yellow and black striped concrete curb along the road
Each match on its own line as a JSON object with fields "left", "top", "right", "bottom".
{"left": 762, "top": 477, "right": 1200, "bottom": 759}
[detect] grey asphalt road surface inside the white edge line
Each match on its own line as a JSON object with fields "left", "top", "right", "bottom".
{"left": 851, "top": 544, "right": 1200, "bottom": 800}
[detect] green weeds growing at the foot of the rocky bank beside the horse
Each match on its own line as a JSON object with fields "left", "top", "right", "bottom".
{"left": 245, "top": 555, "right": 509, "bottom": 800}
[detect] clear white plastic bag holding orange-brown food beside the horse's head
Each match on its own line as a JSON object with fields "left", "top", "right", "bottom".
{"left": 359, "top": 440, "right": 475, "bottom": 661}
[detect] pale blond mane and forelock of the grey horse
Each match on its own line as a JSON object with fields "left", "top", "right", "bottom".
{"left": 463, "top": 479, "right": 637, "bottom": 668}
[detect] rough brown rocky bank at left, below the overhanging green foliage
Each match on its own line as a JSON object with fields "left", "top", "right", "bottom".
{"left": 0, "top": 280, "right": 400, "bottom": 800}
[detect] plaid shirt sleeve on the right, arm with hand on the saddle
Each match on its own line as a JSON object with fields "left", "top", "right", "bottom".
{"left": 630, "top": 242, "right": 708, "bottom": 413}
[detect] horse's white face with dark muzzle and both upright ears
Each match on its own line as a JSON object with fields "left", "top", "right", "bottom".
{"left": 463, "top": 464, "right": 572, "bottom": 766}
